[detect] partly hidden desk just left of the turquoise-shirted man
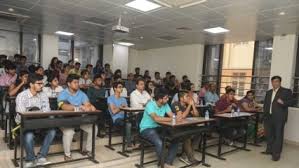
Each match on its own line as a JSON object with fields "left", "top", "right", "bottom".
{"left": 118, "top": 107, "right": 144, "bottom": 157}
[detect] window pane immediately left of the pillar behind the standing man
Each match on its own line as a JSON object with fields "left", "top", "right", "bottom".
{"left": 251, "top": 39, "right": 273, "bottom": 102}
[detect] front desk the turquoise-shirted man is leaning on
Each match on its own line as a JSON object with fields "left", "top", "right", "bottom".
{"left": 158, "top": 117, "right": 215, "bottom": 168}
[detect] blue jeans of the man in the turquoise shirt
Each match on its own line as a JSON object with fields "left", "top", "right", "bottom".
{"left": 141, "top": 128, "right": 178, "bottom": 165}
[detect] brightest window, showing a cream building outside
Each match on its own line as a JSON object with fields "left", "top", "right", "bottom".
{"left": 220, "top": 41, "right": 254, "bottom": 99}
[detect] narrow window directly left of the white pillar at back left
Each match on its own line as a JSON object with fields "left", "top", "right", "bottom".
{"left": 22, "top": 34, "right": 39, "bottom": 64}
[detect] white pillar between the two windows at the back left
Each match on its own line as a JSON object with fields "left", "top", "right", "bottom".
{"left": 41, "top": 34, "right": 58, "bottom": 69}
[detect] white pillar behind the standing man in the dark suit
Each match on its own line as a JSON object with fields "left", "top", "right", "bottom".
{"left": 269, "top": 34, "right": 299, "bottom": 88}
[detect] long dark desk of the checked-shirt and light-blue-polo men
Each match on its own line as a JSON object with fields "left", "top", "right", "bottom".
{"left": 13, "top": 110, "right": 101, "bottom": 168}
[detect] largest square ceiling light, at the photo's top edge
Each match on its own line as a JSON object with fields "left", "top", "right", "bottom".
{"left": 126, "top": 0, "right": 161, "bottom": 12}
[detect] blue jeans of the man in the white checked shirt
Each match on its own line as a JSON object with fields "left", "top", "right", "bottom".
{"left": 24, "top": 129, "right": 56, "bottom": 161}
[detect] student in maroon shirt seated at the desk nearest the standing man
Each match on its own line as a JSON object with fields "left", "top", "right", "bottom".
{"left": 215, "top": 89, "right": 246, "bottom": 145}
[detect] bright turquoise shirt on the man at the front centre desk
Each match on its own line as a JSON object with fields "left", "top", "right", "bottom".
{"left": 140, "top": 101, "right": 171, "bottom": 132}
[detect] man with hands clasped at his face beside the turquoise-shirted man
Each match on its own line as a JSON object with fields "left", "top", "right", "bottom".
{"left": 171, "top": 91, "right": 199, "bottom": 164}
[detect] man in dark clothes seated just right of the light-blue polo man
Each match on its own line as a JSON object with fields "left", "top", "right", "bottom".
{"left": 87, "top": 74, "right": 107, "bottom": 137}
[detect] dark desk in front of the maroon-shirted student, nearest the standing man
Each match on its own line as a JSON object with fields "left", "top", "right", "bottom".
{"left": 207, "top": 112, "right": 254, "bottom": 160}
